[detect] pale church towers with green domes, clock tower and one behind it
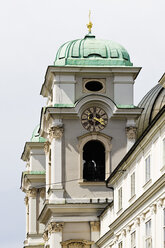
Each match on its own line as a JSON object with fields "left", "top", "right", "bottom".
{"left": 21, "top": 22, "right": 142, "bottom": 248}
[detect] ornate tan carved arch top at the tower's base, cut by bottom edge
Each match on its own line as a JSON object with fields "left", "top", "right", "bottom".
{"left": 61, "top": 239, "right": 94, "bottom": 248}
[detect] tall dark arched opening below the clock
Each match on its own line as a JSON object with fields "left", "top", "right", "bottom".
{"left": 83, "top": 140, "right": 105, "bottom": 181}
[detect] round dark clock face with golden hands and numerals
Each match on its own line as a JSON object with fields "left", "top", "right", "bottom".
{"left": 81, "top": 107, "right": 108, "bottom": 132}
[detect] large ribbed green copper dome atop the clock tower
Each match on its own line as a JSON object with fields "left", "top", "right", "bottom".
{"left": 54, "top": 34, "right": 133, "bottom": 66}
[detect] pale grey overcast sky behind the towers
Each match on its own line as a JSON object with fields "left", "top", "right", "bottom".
{"left": 0, "top": 0, "right": 165, "bottom": 248}
